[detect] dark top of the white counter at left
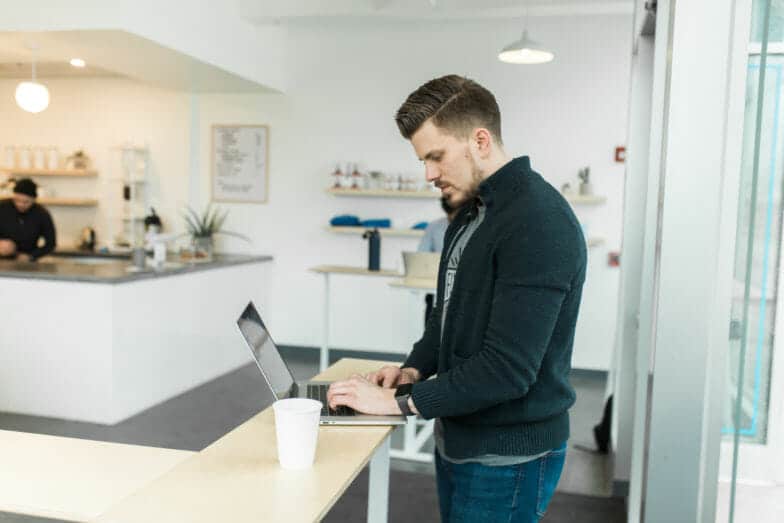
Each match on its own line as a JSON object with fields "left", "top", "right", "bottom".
{"left": 0, "top": 254, "right": 272, "bottom": 284}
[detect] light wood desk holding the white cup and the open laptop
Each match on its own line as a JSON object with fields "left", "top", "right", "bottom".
{"left": 98, "top": 359, "right": 392, "bottom": 523}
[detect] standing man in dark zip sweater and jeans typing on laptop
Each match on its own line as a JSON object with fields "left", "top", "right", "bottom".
{"left": 329, "top": 75, "right": 586, "bottom": 523}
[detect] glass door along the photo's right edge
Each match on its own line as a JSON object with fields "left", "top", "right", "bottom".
{"left": 716, "top": 0, "right": 784, "bottom": 523}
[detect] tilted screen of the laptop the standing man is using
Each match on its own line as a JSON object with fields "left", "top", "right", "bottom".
{"left": 237, "top": 302, "right": 294, "bottom": 399}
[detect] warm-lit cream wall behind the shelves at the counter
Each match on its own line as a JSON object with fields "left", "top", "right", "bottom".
{"left": 0, "top": 79, "right": 190, "bottom": 247}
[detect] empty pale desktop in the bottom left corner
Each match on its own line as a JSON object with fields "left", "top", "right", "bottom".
{"left": 0, "top": 430, "right": 194, "bottom": 521}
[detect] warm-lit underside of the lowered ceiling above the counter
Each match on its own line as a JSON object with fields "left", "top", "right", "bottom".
{"left": 0, "top": 30, "right": 272, "bottom": 92}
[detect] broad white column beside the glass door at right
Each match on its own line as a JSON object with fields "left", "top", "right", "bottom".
{"left": 636, "top": 0, "right": 750, "bottom": 522}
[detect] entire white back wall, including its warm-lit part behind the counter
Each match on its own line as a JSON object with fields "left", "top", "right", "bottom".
{"left": 0, "top": 16, "right": 631, "bottom": 369}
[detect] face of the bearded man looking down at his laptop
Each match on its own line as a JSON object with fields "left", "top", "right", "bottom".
{"left": 411, "top": 120, "right": 482, "bottom": 209}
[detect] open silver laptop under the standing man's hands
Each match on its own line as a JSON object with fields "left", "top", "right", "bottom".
{"left": 237, "top": 302, "right": 406, "bottom": 425}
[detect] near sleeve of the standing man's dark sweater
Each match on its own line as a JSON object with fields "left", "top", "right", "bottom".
{"left": 412, "top": 229, "right": 576, "bottom": 419}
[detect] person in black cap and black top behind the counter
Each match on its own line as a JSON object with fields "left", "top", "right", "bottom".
{"left": 0, "top": 178, "right": 57, "bottom": 261}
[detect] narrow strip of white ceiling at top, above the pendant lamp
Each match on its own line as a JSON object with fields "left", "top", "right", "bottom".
{"left": 239, "top": 0, "right": 634, "bottom": 24}
